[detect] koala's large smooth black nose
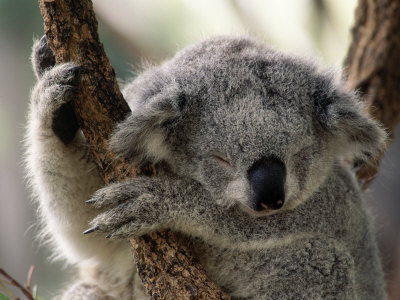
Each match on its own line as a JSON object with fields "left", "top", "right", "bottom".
{"left": 248, "top": 159, "right": 286, "bottom": 211}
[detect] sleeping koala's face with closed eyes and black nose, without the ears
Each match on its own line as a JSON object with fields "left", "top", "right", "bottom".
{"left": 162, "top": 57, "right": 333, "bottom": 215}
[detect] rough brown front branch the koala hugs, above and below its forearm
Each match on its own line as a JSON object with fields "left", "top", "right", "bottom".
{"left": 39, "top": 0, "right": 229, "bottom": 299}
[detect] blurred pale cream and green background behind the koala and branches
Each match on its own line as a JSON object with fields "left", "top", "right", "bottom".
{"left": 0, "top": 0, "right": 400, "bottom": 299}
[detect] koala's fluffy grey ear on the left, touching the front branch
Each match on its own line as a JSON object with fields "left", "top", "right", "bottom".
{"left": 110, "top": 89, "right": 186, "bottom": 164}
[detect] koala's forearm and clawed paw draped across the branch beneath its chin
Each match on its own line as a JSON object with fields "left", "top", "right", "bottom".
{"left": 86, "top": 174, "right": 290, "bottom": 247}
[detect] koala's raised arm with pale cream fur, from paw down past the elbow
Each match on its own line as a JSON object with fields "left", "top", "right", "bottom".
{"left": 26, "top": 39, "right": 134, "bottom": 299}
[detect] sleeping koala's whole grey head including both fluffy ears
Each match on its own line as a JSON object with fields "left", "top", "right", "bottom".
{"left": 111, "top": 37, "right": 385, "bottom": 215}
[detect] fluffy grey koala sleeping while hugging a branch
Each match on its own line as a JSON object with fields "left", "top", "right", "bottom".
{"left": 26, "top": 36, "right": 386, "bottom": 300}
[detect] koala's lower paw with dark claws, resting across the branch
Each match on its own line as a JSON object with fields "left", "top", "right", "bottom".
{"left": 84, "top": 177, "right": 169, "bottom": 238}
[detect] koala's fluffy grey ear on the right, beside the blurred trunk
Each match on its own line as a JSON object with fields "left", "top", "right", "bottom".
{"left": 313, "top": 76, "right": 387, "bottom": 162}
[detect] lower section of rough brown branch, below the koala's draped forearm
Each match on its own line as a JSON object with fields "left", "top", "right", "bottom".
{"left": 134, "top": 231, "right": 230, "bottom": 300}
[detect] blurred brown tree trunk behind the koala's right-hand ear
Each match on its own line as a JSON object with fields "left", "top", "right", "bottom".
{"left": 345, "top": 0, "right": 400, "bottom": 186}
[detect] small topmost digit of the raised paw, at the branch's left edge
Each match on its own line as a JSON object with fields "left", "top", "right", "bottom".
{"left": 32, "top": 35, "right": 56, "bottom": 78}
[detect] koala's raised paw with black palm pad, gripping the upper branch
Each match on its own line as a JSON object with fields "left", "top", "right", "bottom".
{"left": 32, "top": 63, "right": 84, "bottom": 144}
